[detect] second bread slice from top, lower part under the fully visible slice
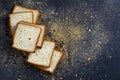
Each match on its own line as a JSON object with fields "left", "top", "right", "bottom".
{"left": 9, "top": 12, "right": 33, "bottom": 35}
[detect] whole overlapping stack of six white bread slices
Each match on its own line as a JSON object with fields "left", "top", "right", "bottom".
{"left": 9, "top": 4, "right": 62, "bottom": 73}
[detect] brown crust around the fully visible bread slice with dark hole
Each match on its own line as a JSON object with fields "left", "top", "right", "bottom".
{"left": 12, "top": 23, "right": 41, "bottom": 53}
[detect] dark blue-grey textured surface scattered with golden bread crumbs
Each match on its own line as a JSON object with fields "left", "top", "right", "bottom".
{"left": 0, "top": 0, "right": 120, "bottom": 80}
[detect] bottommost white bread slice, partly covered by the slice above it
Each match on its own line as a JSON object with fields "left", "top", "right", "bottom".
{"left": 37, "top": 50, "right": 63, "bottom": 73}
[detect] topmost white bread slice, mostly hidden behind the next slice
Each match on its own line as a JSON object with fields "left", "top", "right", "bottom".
{"left": 12, "top": 4, "right": 40, "bottom": 23}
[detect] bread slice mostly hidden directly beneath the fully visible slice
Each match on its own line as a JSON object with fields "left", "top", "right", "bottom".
{"left": 18, "top": 21, "right": 46, "bottom": 48}
